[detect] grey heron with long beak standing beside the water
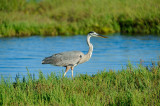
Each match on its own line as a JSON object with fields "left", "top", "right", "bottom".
{"left": 42, "top": 31, "right": 107, "bottom": 77}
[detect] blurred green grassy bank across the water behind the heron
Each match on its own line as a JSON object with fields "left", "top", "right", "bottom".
{"left": 0, "top": 0, "right": 160, "bottom": 37}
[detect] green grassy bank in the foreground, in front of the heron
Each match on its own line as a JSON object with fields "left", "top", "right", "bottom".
{"left": 0, "top": 65, "right": 160, "bottom": 106}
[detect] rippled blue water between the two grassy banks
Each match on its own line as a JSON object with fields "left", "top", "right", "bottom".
{"left": 0, "top": 34, "right": 160, "bottom": 78}
